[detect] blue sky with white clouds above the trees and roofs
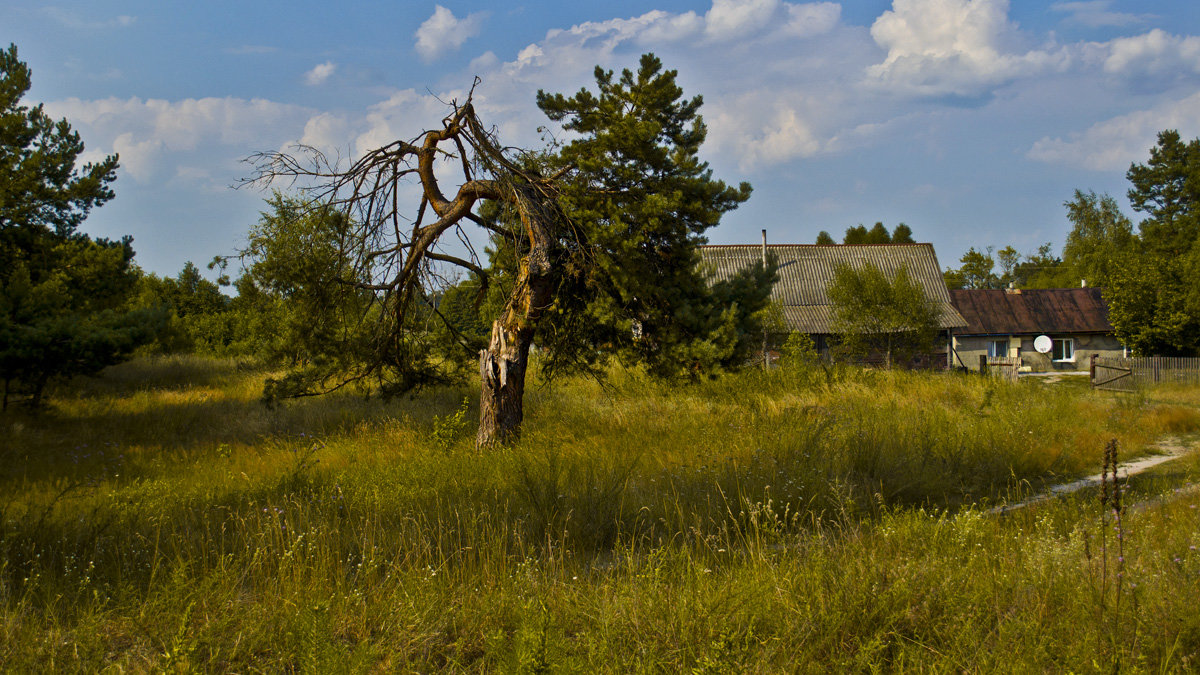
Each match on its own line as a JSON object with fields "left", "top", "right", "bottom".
{"left": 7, "top": 0, "right": 1200, "bottom": 275}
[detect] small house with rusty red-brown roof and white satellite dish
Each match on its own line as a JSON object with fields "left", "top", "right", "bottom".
{"left": 950, "top": 287, "right": 1126, "bottom": 371}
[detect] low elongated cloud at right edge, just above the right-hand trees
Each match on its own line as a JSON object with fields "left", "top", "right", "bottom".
{"left": 1026, "top": 94, "right": 1200, "bottom": 171}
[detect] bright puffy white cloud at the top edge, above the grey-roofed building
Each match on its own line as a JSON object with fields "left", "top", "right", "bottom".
{"left": 868, "top": 0, "right": 1066, "bottom": 96}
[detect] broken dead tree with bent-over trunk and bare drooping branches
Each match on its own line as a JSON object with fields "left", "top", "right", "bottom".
{"left": 248, "top": 90, "right": 570, "bottom": 447}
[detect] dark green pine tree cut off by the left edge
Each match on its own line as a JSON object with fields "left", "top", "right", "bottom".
{"left": 0, "top": 46, "right": 159, "bottom": 407}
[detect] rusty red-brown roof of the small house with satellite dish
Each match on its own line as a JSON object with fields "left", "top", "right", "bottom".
{"left": 950, "top": 288, "right": 1112, "bottom": 335}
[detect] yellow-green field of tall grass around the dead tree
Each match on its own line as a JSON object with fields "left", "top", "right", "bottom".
{"left": 0, "top": 358, "right": 1200, "bottom": 673}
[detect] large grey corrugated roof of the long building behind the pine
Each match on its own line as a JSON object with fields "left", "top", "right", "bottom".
{"left": 700, "top": 244, "right": 967, "bottom": 334}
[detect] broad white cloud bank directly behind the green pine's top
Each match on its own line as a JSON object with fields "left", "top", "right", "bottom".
{"left": 444, "top": 0, "right": 864, "bottom": 169}
